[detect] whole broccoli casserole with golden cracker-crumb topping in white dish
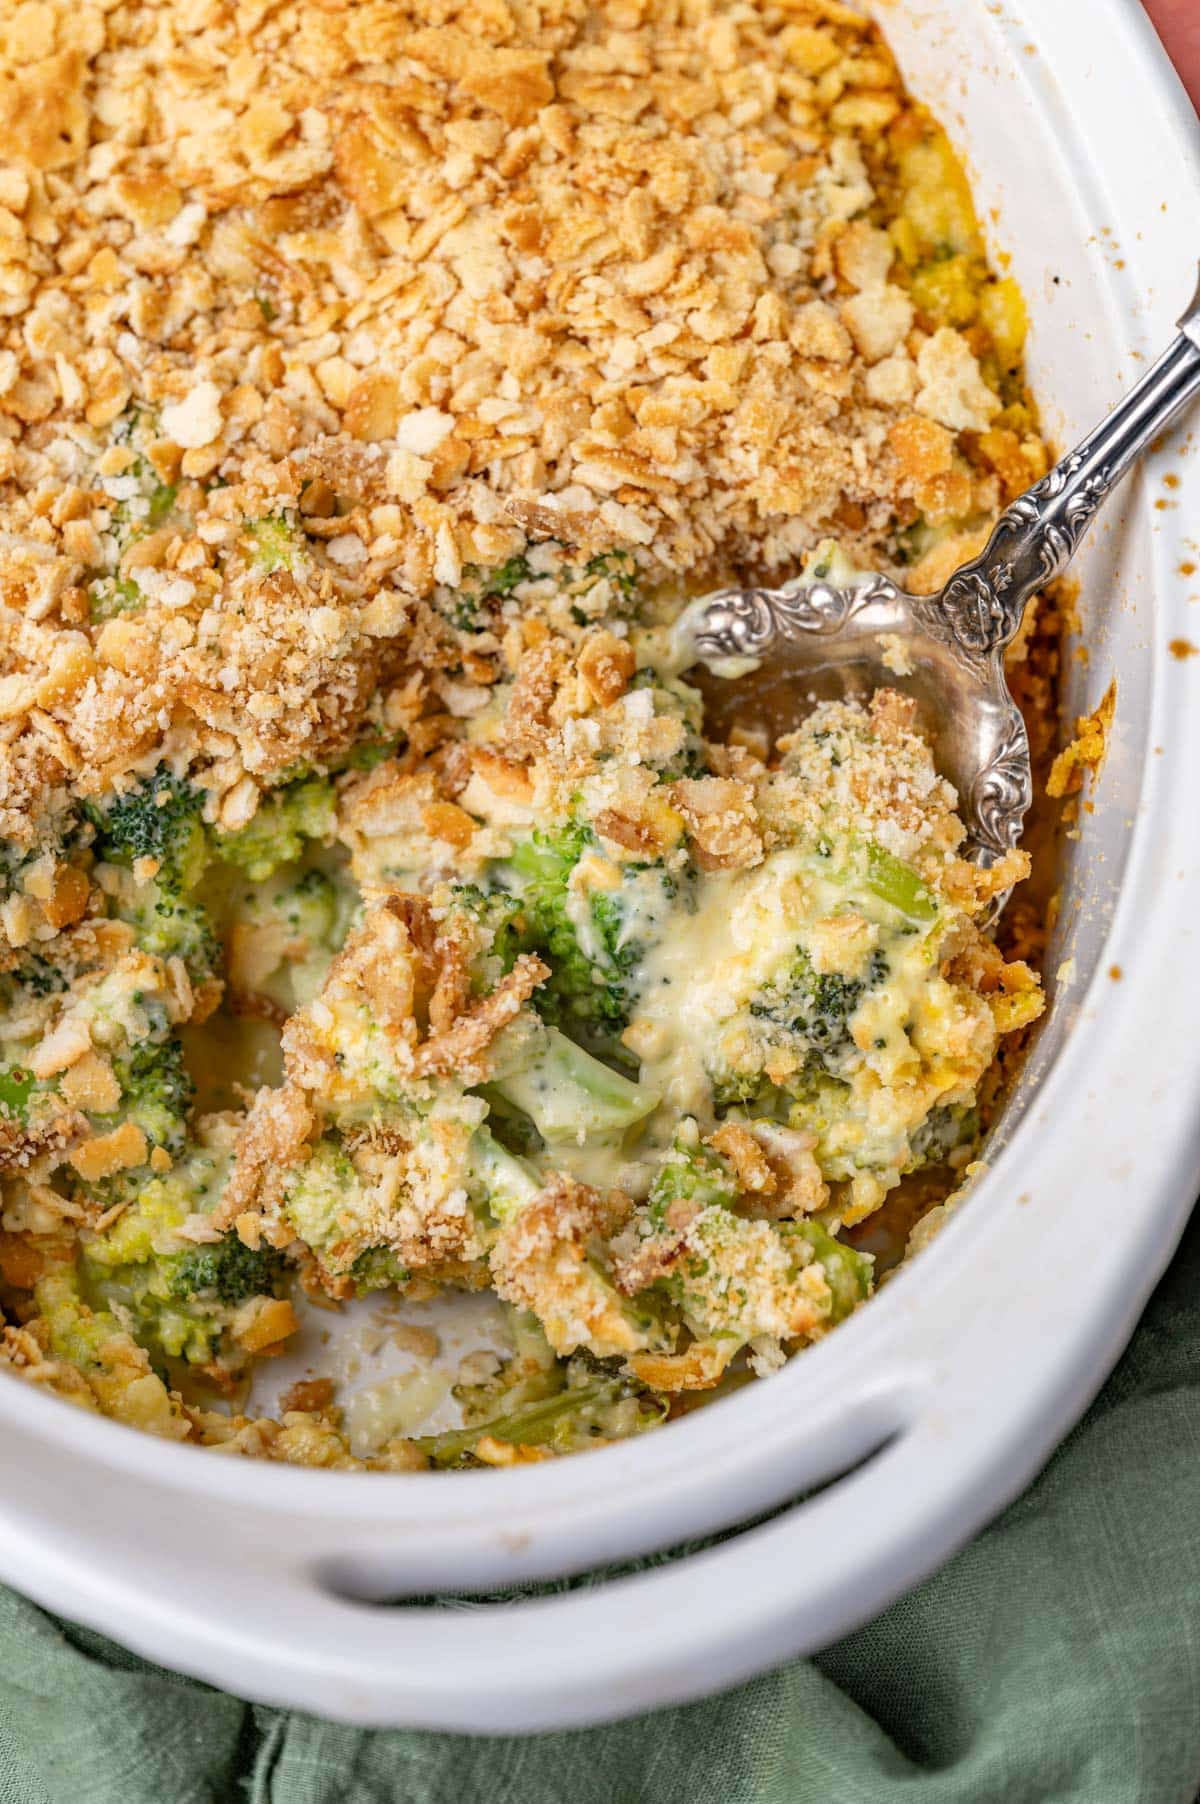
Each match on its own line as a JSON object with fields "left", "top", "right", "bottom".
{"left": 0, "top": 0, "right": 1047, "bottom": 1468}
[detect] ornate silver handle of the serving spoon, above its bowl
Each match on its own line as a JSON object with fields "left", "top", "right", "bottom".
{"left": 940, "top": 270, "right": 1200, "bottom": 655}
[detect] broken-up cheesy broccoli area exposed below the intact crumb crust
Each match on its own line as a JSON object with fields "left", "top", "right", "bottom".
{"left": 0, "top": 566, "right": 1041, "bottom": 1465}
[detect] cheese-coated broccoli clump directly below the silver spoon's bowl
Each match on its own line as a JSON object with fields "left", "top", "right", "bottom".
{"left": 613, "top": 797, "right": 996, "bottom": 1220}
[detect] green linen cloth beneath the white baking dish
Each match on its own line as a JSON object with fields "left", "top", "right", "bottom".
{"left": 0, "top": 1216, "right": 1200, "bottom": 1804}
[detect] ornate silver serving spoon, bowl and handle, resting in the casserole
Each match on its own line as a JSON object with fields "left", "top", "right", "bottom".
{"left": 688, "top": 270, "right": 1200, "bottom": 891}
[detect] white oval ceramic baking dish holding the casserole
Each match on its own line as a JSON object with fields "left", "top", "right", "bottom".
{"left": 0, "top": 0, "right": 1200, "bottom": 1732}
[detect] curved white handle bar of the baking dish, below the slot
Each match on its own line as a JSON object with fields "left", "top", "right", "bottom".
{"left": 7, "top": 1407, "right": 978, "bottom": 1734}
